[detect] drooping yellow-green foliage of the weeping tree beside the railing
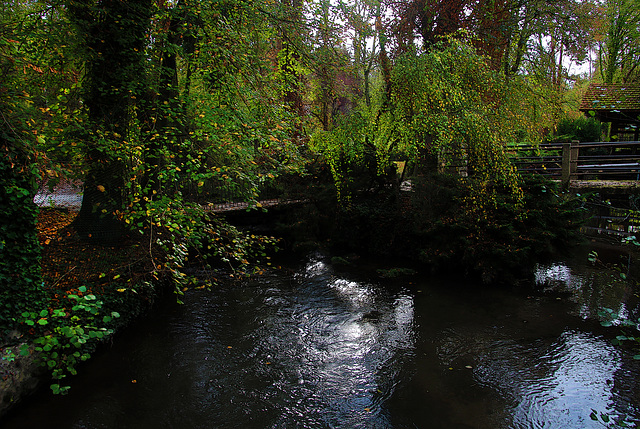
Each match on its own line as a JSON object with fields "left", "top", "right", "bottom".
{"left": 312, "top": 37, "right": 535, "bottom": 206}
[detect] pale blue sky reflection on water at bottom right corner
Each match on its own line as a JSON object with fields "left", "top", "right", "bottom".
{"left": 475, "top": 331, "right": 631, "bottom": 428}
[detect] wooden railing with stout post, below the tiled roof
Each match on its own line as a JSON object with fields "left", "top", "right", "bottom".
{"left": 509, "top": 141, "right": 640, "bottom": 186}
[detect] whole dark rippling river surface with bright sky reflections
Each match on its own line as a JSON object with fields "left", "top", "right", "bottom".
{"left": 2, "top": 249, "right": 640, "bottom": 429}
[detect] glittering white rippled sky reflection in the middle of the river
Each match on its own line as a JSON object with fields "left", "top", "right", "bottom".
{"left": 269, "top": 254, "right": 414, "bottom": 427}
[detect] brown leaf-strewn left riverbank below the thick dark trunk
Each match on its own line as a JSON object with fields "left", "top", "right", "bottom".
{"left": 0, "top": 209, "right": 157, "bottom": 416}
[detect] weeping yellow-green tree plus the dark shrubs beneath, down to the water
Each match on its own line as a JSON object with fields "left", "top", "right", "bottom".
{"left": 311, "top": 33, "right": 582, "bottom": 282}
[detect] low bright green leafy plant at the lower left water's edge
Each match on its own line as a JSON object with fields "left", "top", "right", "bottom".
{"left": 20, "top": 286, "right": 120, "bottom": 394}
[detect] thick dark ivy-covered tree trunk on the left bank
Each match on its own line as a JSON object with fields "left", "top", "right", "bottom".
{"left": 67, "top": 0, "right": 152, "bottom": 244}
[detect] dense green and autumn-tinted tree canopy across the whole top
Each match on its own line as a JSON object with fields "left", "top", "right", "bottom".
{"left": 0, "top": 0, "right": 640, "bottom": 318}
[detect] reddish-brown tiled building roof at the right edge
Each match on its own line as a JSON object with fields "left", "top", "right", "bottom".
{"left": 580, "top": 83, "right": 640, "bottom": 117}
